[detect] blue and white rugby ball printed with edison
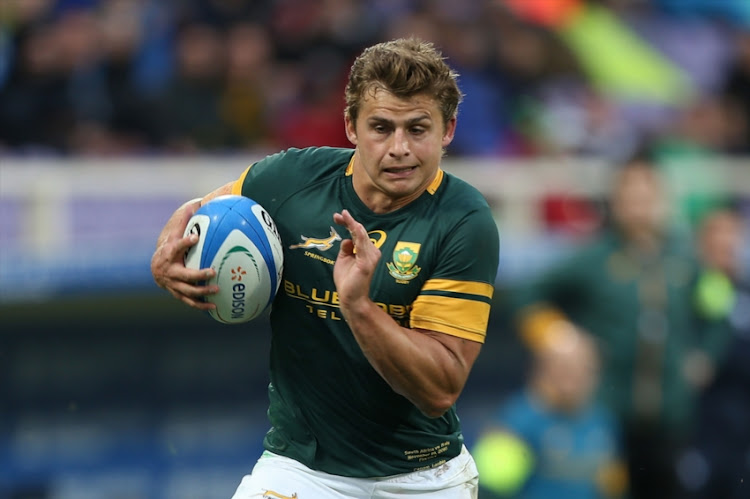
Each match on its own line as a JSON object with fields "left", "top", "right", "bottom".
{"left": 184, "top": 195, "right": 284, "bottom": 324}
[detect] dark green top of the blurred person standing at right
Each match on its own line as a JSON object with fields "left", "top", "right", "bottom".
{"left": 509, "top": 232, "right": 730, "bottom": 433}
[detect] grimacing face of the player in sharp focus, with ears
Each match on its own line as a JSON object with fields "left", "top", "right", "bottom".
{"left": 346, "top": 89, "right": 456, "bottom": 213}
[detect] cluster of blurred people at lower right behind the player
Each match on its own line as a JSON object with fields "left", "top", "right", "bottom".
{"left": 474, "top": 156, "right": 750, "bottom": 499}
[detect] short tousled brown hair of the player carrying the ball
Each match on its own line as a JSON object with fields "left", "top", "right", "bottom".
{"left": 344, "top": 38, "right": 463, "bottom": 124}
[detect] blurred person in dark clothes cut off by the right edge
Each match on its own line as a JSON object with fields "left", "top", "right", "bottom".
{"left": 681, "top": 208, "right": 750, "bottom": 499}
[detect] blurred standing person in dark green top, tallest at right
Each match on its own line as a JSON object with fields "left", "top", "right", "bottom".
{"left": 509, "top": 156, "right": 728, "bottom": 499}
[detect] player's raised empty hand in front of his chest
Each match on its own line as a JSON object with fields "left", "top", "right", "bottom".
{"left": 333, "top": 210, "right": 380, "bottom": 307}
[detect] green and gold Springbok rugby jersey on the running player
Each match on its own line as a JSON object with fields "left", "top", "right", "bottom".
{"left": 233, "top": 147, "right": 498, "bottom": 477}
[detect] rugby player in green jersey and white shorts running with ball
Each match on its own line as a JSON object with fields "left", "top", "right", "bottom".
{"left": 151, "top": 39, "right": 498, "bottom": 499}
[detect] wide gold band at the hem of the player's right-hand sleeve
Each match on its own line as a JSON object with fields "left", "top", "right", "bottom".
{"left": 410, "top": 295, "right": 490, "bottom": 343}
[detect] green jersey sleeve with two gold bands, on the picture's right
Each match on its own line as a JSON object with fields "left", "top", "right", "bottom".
{"left": 410, "top": 206, "right": 499, "bottom": 343}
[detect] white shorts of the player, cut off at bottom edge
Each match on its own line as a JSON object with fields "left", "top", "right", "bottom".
{"left": 232, "top": 446, "right": 479, "bottom": 499}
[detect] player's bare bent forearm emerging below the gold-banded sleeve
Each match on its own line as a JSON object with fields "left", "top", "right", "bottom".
{"left": 342, "top": 299, "right": 480, "bottom": 417}
